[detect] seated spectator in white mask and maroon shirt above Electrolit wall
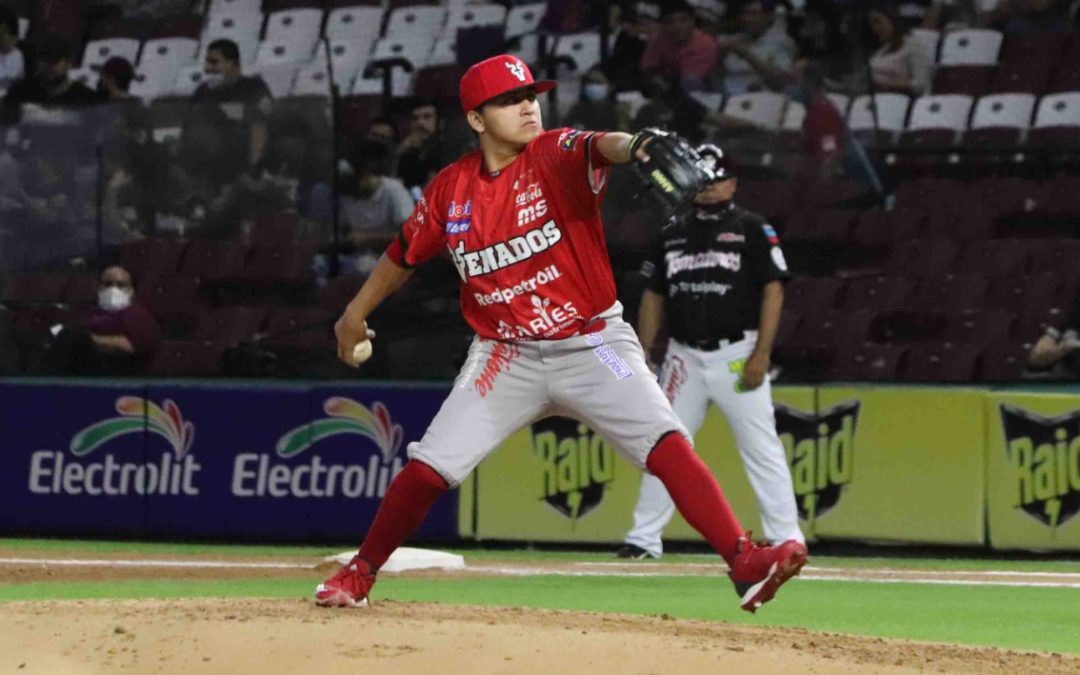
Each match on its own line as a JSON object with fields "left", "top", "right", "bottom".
{"left": 33, "top": 265, "right": 161, "bottom": 376}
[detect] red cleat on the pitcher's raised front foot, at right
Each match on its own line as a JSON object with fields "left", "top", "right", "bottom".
{"left": 728, "top": 532, "right": 807, "bottom": 613}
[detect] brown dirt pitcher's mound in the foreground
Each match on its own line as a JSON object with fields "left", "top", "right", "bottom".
{"left": 0, "top": 599, "right": 1080, "bottom": 675}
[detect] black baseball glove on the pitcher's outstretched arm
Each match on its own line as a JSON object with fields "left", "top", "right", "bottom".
{"left": 630, "top": 129, "right": 714, "bottom": 212}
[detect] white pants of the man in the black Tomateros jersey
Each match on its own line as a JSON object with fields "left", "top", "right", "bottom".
{"left": 626, "top": 332, "right": 806, "bottom": 557}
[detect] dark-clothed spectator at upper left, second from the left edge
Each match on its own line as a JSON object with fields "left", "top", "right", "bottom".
{"left": 0, "top": 36, "right": 98, "bottom": 124}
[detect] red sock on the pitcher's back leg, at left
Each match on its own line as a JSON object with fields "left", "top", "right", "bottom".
{"left": 360, "top": 460, "right": 448, "bottom": 573}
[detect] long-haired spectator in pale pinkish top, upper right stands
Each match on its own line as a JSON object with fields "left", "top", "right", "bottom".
{"left": 867, "top": 4, "right": 933, "bottom": 96}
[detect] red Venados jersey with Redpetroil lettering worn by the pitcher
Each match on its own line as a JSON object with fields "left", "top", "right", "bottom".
{"left": 387, "top": 129, "right": 616, "bottom": 340}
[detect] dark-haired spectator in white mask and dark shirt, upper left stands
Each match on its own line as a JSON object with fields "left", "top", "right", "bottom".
{"left": 180, "top": 40, "right": 273, "bottom": 187}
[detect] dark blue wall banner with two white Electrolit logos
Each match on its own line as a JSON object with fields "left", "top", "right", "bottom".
{"left": 0, "top": 382, "right": 458, "bottom": 541}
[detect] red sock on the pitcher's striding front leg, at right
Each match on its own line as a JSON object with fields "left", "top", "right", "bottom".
{"left": 646, "top": 432, "right": 743, "bottom": 566}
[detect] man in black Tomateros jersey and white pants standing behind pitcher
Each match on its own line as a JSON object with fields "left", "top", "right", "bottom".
{"left": 616, "top": 144, "right": 806, "bottom": 559}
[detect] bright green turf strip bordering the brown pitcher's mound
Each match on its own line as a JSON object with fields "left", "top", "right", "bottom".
{"left": 0, "top": 576, "right": 1080, "bottom": 653}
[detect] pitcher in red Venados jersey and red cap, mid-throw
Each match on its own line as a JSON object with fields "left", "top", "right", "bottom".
{"left": 315, "top": 55, "right": 807, "bottom": 611}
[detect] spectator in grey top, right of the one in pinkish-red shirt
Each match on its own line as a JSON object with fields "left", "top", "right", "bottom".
{"left": 716, "top": 0, "right": 797, "bottom": 96}
